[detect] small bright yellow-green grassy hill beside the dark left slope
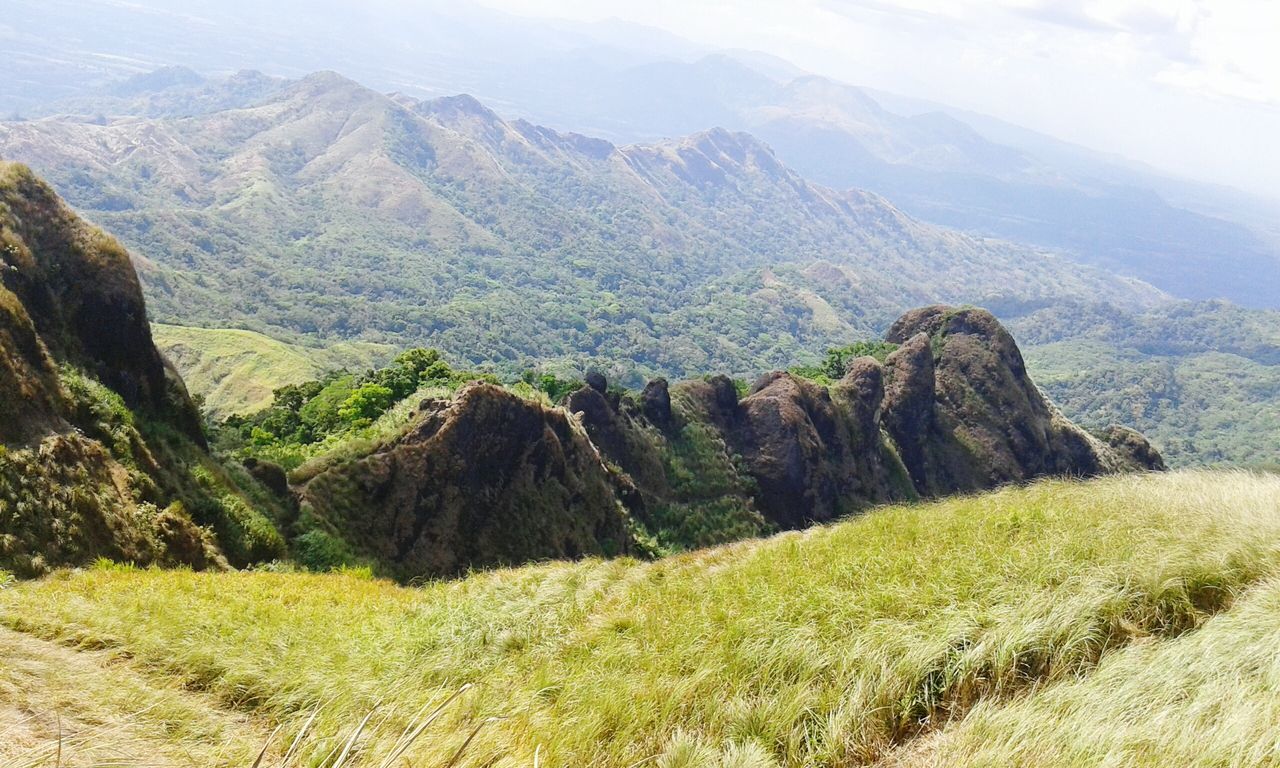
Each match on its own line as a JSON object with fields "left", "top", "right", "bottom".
{"left": 151, "top": 324, "right": 394, "bottom": 419}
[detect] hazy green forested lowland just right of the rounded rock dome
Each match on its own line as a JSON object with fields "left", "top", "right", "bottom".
{"left": 1010, "top": 302, "right": 1280, "bottom": 466}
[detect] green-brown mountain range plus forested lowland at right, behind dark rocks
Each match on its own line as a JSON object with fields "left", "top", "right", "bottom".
{"left": 0, "top": 69, "right": 1280, "bottom": 463}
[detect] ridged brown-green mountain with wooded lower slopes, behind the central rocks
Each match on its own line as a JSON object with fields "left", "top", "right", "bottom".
{"left": 0, "top": 73, "right": 1161, "bottom": 380}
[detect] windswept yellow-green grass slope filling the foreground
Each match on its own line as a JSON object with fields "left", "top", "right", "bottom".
{"left": 0, "top": 472, "right": 1280, "bottom": 768}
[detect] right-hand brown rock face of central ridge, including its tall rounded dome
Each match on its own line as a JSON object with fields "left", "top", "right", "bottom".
{"left": 568, "top": 306, "right": 1164, "bottom": 529}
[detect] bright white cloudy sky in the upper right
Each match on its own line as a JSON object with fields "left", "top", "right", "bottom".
{"left": 483, "top": 0, "right": 1280, "bottom": 198}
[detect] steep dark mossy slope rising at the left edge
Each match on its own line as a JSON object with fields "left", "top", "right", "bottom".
{"left": 0, "top": 164, "right": 283, "bottom": 575}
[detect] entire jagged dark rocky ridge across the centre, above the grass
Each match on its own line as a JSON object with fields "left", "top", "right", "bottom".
{"left": 296, "top": 306, "right": 1164, "bottom": 579}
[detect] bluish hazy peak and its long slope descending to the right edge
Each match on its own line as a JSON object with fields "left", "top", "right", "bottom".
{"left": 501, "top": 55, "right": 1280, "bottom": 307}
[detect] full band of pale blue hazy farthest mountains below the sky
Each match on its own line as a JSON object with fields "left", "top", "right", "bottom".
{"left": 0, "top": 0, "right": 1280, "bottom": 307}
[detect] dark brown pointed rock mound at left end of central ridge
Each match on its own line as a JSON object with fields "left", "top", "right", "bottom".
{"left": 301, "top": 384, "right": 634, "bottom": 577}
